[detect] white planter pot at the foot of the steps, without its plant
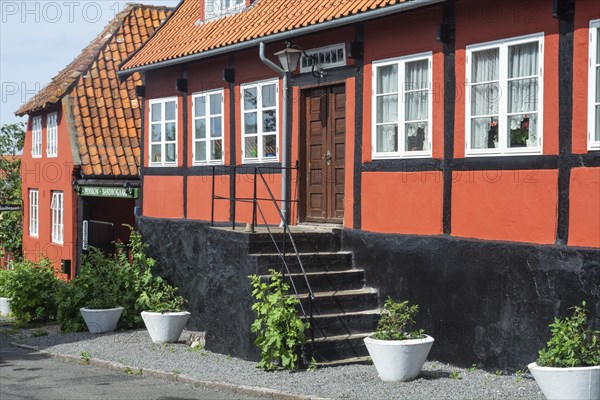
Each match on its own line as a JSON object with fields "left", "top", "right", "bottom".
{"left": 365, "top": 335, "right": 433, "bottom": 382}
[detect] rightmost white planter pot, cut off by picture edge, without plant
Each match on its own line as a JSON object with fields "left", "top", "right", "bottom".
{"left": 527, "top": 363, "right": 600, "bottom": 400}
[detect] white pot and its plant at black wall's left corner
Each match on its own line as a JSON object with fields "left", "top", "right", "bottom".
{"left": 138, "top": 276, "right": 190, "bottom": 344}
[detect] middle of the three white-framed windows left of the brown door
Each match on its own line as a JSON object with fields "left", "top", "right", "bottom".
{"left": 192, "top": 89, "right": 225, "bottom": 165}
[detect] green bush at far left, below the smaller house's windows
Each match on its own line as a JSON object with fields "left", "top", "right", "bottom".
{"left": 6, "top": 259, "right": 59, "bottom": 325}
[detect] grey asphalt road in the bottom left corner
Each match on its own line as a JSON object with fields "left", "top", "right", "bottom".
{"left": 0, "top": 340, "right": 266, "bottom": 400}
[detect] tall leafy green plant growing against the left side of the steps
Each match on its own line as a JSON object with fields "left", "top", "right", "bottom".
{"left": 249, "top": 269, "right": 309, "bottom": 371}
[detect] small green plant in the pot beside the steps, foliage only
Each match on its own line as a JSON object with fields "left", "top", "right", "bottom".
{"left": 373, "top": 297, "right": 424, "bottom": 340}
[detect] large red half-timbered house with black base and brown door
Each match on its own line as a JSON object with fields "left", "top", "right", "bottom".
{"left": 119, "top": 0, "right": 600, "bottom": 368}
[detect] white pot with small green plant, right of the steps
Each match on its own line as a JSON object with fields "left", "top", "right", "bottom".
{"left": 364, "top": 297, "right": 433, "bottom": 382}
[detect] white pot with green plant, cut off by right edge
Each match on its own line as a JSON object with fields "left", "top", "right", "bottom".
{"left": 528, "top": 301, "right": 600, "bottom": 400}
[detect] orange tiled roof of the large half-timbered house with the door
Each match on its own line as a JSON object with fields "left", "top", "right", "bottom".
{"left": 121, "top": 0, "right": 424, "bottom": 71}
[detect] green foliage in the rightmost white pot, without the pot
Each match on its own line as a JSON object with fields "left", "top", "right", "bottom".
{"left": 537, "top": 301, "right": 600, "bottom": 367}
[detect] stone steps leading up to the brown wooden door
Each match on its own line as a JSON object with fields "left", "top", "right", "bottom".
{"left": 249, "top": 230, "right": 379, "bottom": 365}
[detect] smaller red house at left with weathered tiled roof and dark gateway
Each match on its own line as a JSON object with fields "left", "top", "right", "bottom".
{"left": 16, "top": 5, "right": 170, "bottom": 279}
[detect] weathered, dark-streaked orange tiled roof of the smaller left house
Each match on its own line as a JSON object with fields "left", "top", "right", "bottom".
{"left": 16, "top": 4, "right": 171, "bottom": 175}
